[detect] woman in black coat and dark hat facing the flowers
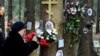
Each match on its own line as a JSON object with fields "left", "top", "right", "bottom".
{"left": 3, "top": 22, "right": 38, "bottom": 56}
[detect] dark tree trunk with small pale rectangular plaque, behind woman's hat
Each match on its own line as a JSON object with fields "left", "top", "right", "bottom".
{"left": 25, "top": 0, "right": 35, "bottom": 33}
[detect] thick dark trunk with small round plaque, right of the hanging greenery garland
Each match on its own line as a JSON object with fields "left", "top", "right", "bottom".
{"left": 78, "top": 0, "right": 96, "bottom": 56}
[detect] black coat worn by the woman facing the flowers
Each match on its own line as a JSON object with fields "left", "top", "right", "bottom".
{"left": 2, "top": 32, "right": 38, "bottom": 56}
